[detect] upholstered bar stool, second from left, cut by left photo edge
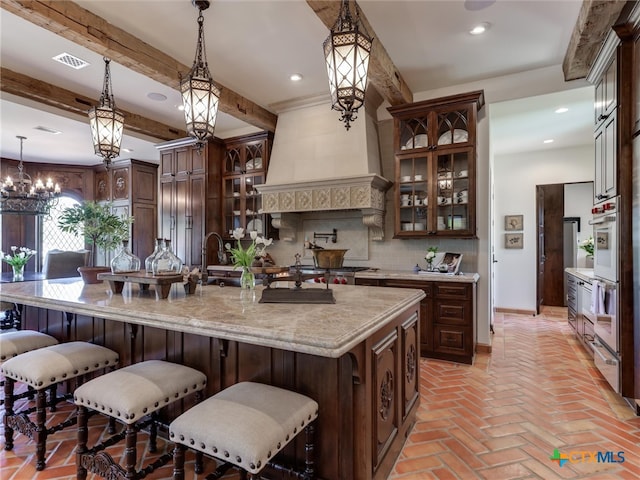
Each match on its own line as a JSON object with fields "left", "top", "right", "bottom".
{"left": 0, "top": 342, "right": 118, "bottom": 470}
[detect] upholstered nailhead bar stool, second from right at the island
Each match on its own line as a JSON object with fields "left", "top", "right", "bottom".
{"left": 73, "top": 360, "right": 207, "bottom": 480}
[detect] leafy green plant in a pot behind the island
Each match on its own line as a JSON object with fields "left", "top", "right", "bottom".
{"left": 58, "top": 201, "right": 133, "bottom": 283}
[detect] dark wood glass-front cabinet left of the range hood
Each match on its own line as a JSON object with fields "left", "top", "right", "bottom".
{"left": 222, "top": 132, "right": 272, "bottom": 238}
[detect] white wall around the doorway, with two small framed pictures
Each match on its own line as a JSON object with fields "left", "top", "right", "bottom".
{"left": 494, "top": 145, "right": 594, "bottom": 311}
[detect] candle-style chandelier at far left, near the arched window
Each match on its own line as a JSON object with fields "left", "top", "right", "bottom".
{"left": 0, "top": 136, "right": 60, "bottom": 215}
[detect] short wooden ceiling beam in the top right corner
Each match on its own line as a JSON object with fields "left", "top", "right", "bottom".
{"left": 562, "top": 0, "right": 627, "bottom": 81}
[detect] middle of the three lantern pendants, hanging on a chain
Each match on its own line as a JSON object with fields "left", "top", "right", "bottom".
{"left": 180, "top": 0, "right": 220, "bottom": 148}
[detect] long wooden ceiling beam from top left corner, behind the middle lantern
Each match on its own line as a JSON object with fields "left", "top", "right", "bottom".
{"left": 1, "top": 0, "right": 278, "bottom": 131}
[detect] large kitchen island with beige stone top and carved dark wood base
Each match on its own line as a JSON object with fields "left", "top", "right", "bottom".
{"left": 0, "top": 279, "right": 424, "bottom": 480}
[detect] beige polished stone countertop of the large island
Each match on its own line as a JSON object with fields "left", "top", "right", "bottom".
{"left": 0, "top": 279, "right": 424, "bottom": 358}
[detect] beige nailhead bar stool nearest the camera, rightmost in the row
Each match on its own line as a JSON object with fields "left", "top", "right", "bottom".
{"left": 169, "top": 382, "right": 318, "bottom": 480}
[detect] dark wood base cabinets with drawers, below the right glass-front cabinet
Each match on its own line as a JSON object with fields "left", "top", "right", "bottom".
{"left": 356, "top": 278, "right": 476, "bottom": 363}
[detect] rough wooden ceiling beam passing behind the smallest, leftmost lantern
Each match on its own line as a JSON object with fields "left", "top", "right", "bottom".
{"left": 0, "top": 67, "right": 187, "bottom": 140}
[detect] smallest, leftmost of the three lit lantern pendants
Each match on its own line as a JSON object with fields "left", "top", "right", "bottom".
{"left": 89, "top": 57, "right": 124, "bottom": 166}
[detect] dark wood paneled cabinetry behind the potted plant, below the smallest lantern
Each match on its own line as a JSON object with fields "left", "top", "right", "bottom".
{"left": 94, "top": 159, "right": 158, "bottom": 265}
